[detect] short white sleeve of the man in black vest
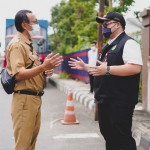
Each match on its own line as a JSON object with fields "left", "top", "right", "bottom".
{"left": 122, "top": 39, "right": 143, "bottom": 65}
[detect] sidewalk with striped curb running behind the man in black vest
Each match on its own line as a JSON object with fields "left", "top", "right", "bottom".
{"left": 48, "top": 74, "right": 150, "bottom": 150}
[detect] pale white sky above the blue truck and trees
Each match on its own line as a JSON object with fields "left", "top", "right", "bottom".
{"left": 0, "top": 0, "right": 150, "bottom": 55}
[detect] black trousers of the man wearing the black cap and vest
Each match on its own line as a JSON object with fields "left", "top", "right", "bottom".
{"left": 98, "top": 104, "right": 136, "bottom": 150}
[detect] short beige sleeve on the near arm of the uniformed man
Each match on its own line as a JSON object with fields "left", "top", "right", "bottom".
{"left": 10, "top": 45, "right": 25, "bottom": 76}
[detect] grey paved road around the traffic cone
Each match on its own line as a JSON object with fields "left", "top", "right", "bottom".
{"left": 0, "top": 80, "right": 105, "bottom": 150}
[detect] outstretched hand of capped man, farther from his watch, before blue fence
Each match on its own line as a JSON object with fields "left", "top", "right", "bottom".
{"left": 68, "top": 57, "right": 85, "bottom": 70}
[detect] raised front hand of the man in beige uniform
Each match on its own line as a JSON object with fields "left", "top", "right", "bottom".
{"left": 42, "top": 53, "right": 63, "bottom": 71}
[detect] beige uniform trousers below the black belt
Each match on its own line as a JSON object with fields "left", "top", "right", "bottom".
{"left": 11, "top": 93, "right": 42, "bottom": 150}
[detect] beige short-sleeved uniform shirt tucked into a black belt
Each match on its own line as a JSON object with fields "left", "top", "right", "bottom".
{"left": 6, "top": 32, "right": 44, "bottom": 92}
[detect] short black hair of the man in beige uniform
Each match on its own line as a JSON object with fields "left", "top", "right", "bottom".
{"left": 15, "top": 10, "right": 32, "bottom": 32}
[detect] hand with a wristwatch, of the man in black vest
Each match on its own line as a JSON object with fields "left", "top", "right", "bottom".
{"left": 88, "top": 60, "right": 107, "bottom": 76}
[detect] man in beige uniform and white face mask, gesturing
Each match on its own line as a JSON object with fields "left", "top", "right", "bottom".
{"left": 6, "top": 10, "right": 63, "bottom": 150}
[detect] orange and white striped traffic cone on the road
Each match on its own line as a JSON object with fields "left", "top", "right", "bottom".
{"left": 61, "top": 92, "right": 79, "bottom": 125}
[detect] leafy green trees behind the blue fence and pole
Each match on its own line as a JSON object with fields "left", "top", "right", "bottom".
{"left": 49, "top": 0, "right": 134, "bottom": 54}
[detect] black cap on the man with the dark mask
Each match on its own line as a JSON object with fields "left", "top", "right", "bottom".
{"left": 96, "top": 11, "right": 126, "bottom": 27}
